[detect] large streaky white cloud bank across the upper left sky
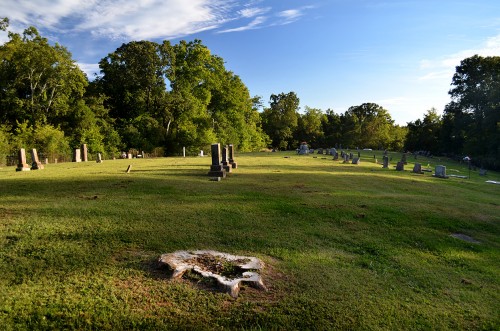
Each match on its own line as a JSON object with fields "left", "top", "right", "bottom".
{"left": 0, "top": 0, "right": 316, "bottom": 40}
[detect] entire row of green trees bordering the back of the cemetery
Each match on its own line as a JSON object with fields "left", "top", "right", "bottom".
{"left": 0, "top": 18, "right": 500, "bottom": 167}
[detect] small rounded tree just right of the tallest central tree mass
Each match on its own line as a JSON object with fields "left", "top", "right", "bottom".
{"left": 261, "top": 92, "right": 300, "bottom": 150}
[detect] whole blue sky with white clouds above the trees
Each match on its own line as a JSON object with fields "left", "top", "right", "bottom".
{"left": 0, "top": 0, "right": 500, "bottom": 124}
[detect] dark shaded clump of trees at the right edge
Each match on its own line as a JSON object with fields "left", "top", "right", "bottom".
{"left": 405, "top": 55, "right": 500, "bottom": 169}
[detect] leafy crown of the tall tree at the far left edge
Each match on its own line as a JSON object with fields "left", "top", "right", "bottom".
{"left": 0, "top": 27, "right": 87, "bottom": 129}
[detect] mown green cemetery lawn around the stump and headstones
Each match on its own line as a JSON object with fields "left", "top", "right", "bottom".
{"left": 0, "top": 152, "right": 500, "bottom": 330}
